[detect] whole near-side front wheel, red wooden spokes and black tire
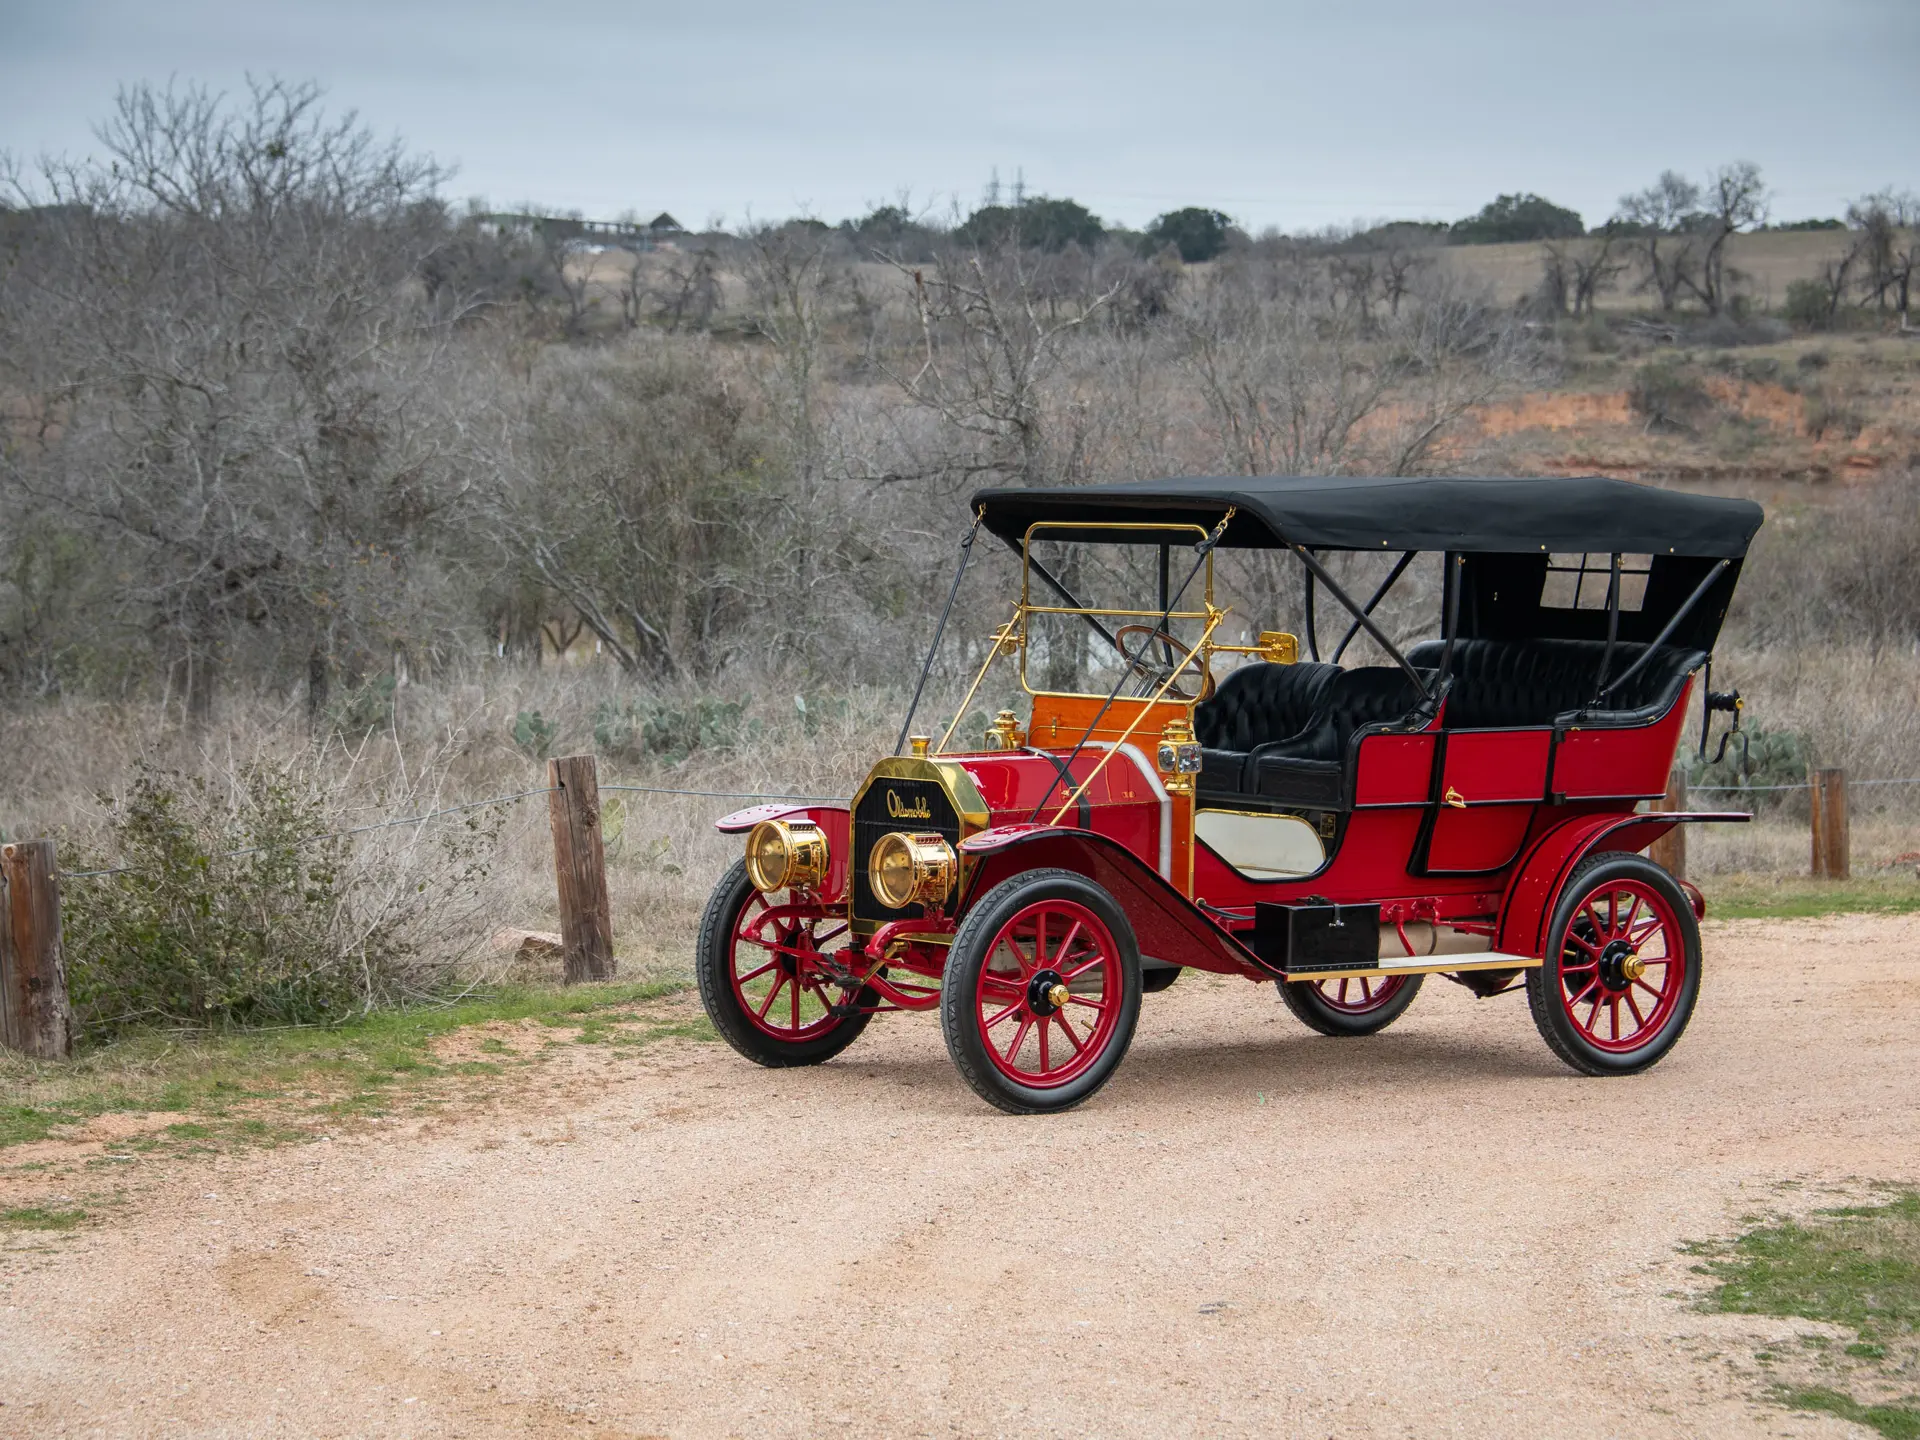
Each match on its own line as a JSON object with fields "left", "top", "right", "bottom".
{"left": 941, "top": 870, "right": 1140, "bottom": 1116}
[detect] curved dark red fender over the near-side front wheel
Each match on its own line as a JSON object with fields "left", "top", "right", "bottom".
{"left": 958, "top": 826, "right": 1279, "bottom": 979}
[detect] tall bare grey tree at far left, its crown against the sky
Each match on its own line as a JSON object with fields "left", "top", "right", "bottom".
{"left": 0, "top": 83, "right": 461, "bottom": 720}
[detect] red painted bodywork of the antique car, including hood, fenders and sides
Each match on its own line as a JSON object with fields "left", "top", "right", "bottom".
{"left": 720, "top": 682, "right": 1747, "bottom": 1008}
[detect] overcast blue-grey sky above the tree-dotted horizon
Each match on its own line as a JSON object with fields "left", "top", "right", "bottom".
{"left": 0, "top": 0, "right": 1920, "bottom": 228}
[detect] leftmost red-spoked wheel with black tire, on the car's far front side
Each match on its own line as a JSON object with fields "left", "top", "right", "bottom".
{"left": 695, "top": 860, "right": 870, "bottom": 1066}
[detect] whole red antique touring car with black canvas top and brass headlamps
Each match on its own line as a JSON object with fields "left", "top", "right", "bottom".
{"left": 697, "top": 478, "right": 1761, "bottom": 1114}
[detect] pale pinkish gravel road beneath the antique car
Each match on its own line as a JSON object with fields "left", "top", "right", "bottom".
{"left": 0, "top": 918, "right": 1920, "bottom": 1436}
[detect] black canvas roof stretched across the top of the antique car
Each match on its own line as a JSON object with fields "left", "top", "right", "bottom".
{"left": 973, "top": 474, "right": 1761, "bottom": 559}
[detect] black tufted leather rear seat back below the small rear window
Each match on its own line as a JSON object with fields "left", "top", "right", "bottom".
{"left": 1407, "top": 639, "right": 1707, "bottom": 730}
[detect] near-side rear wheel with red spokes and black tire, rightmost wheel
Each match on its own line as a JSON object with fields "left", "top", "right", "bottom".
{"left": 1526, "top": 852, "right": 1699, "bottom": 1075}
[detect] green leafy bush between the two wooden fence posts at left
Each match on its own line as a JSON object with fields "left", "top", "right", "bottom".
{"left": 61, "top": 762, "right": 503, "bottom": 1039}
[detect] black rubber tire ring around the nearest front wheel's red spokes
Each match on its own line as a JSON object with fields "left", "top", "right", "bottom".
{"left": 941, "top": 870, "right": 1140, "bottom": 1116}
